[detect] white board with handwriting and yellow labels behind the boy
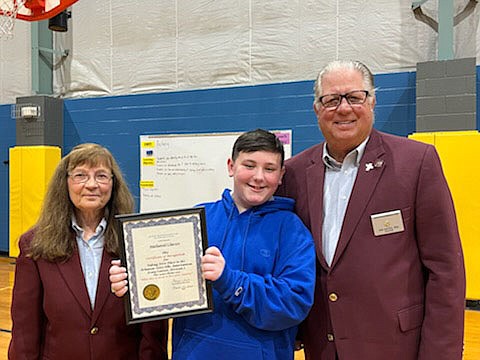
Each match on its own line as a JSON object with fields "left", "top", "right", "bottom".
{"left": 140, "top": 130, "right": 292, "bottom": 212}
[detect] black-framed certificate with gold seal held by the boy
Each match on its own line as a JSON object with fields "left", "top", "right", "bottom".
{"left": 115, "top": 207, "right": 213, "bottom": 324}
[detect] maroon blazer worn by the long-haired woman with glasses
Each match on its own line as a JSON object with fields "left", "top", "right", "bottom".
{"left": 8, "top": 231, "right": 167, "bottom": 360}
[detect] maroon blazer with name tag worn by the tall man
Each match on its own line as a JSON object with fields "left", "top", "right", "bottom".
{"left": 278, "top": 130, "right": 465, "bottom": 360}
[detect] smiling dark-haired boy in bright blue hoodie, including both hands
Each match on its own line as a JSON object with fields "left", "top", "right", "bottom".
{"left": 110, "top": 129, "right": 315, "bottom": 360}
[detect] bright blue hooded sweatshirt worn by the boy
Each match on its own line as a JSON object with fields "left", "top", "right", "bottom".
{"left": 172, "top": 189, "right": 315, "bottom": 360}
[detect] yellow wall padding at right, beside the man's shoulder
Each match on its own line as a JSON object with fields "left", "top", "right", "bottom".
{"left": 410, "top": 131, "right": 480, "bottom": 300}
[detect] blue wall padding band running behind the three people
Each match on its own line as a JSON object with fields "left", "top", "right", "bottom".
{"left": 0, "top": 68, "right": 470, "bottom": 251}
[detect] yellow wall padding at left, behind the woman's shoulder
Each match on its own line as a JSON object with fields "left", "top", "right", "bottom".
{"left": 9, "top": 146, "right": 61, "bottom": 257}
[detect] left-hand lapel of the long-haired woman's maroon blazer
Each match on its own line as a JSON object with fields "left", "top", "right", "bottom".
{"left": 56, "top": 250, "right": 92, "bottom": 316}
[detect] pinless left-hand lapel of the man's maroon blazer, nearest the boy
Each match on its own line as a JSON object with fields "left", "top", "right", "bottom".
{"left": 306, "top": 145, "right": 328, "bottom": 271}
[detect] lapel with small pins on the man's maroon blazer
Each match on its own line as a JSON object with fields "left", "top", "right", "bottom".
{"left": 331, "top": 130, "right": 388, "bottom": 268}
